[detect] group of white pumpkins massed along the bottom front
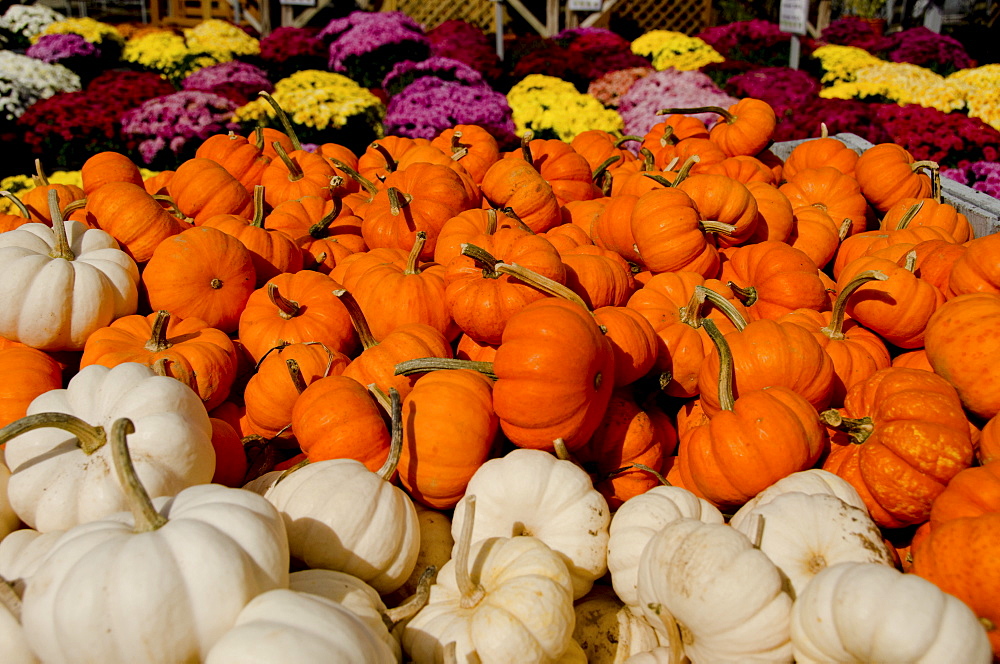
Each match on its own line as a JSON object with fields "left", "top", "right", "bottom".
{"left": 0, "top": 363, "right": 992, "bottom": 664}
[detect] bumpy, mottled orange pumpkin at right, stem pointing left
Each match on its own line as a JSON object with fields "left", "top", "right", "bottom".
{"left": 822, "top": 367, "right": 973, "bottom": 528}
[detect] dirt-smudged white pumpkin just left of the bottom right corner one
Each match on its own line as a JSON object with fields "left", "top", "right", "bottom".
{"left": 638, "top": 519, "right": 792, "bottom": 664}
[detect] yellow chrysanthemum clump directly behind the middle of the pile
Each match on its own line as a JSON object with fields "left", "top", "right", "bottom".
{"left": 507, "top": 74, "right": 624, "bottom": 141}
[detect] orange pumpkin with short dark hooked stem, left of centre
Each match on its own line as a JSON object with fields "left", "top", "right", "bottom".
{"left": 239, "top": 270, "right": 358, "bottom": 362}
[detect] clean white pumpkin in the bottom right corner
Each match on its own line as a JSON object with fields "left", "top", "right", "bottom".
{"left": 792, "top": 562, "right": 993, "bottom": 664}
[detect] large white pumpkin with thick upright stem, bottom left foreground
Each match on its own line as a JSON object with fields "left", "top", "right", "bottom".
{"left": 21, "top": 419, "right": 289, "bottom": 664}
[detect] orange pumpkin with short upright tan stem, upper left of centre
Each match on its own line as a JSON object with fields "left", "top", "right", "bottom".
{"left": 351, "top": 231, "right": 460, "bottom": 341}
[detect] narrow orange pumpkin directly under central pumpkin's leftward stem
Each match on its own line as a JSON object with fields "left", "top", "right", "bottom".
{"left": 396, "top": 369, "right": 499, "bottom": 510}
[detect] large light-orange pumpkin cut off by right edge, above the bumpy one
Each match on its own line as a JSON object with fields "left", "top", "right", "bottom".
{"left": 924, "top": 293, "right": 1000, "bottom": 419}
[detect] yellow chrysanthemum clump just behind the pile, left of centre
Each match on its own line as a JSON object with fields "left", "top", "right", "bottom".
{"left": 234, "top": 69, "right": 385, "bottom": 130}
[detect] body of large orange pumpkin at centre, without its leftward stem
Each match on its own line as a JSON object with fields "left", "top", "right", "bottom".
{"left": 493, "top": 297, "right": 615, "bottom": 451}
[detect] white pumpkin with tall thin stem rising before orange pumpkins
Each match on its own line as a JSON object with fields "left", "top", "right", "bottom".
{"left": 253, "top": 389, "right": 420, "bottom": 595}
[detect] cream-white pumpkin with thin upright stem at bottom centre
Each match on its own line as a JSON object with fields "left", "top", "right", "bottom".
{"left": 403, "top": 494, "right": 578, "bottom": 664}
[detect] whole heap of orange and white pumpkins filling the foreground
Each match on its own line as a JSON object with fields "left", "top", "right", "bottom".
{"left": 0, "top": 94, "right": 1000, "bottom": 664}
